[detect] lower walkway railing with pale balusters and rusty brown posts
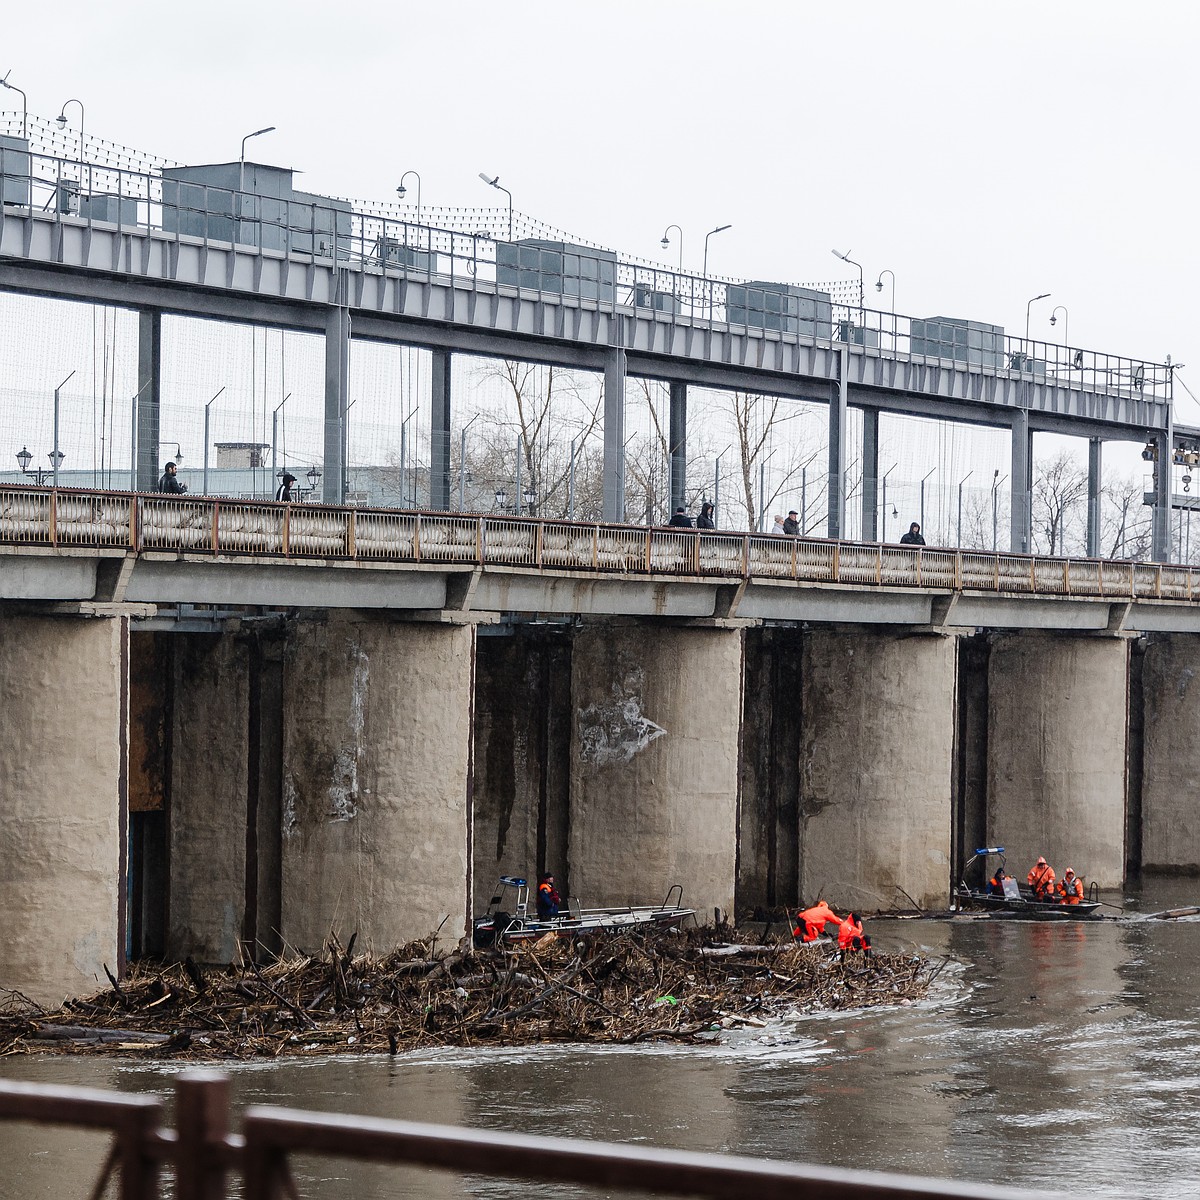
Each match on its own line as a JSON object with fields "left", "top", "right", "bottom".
{"left": 0, "top": 486, "right": 1200, "bottom": 601}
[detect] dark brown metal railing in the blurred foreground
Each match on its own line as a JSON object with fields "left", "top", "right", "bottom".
{"left": 0, "top": 1070, "right": 1039, "bottom": 1200}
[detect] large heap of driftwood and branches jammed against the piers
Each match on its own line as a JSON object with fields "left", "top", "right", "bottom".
{"left": 0, "top": 928, "right": 941, "bottom": 1060}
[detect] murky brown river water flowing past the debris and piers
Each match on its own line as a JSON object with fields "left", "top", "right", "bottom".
{"left": 0, "top": 880, "right": 1200, "bottom": 1200}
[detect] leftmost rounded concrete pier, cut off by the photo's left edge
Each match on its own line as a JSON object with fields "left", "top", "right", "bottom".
{"left": 0, "top": 616, "right": 128, "bottom": 1006}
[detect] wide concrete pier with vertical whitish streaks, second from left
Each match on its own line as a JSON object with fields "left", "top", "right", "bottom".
{"left": 282, "top": 619, "right": 475, "bottom": 952}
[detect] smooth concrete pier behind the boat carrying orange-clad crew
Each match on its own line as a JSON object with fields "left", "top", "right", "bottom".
{"left": 988, "top": 634, "right": 1128, "bottom": 888}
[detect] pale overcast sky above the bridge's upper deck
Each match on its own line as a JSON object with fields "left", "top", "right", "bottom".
{"left": 0, "top": 0, "right": 1200, "bottom": 532}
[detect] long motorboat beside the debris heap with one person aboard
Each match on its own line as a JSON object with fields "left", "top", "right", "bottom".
{"left": 473, "top": 875, "right": 696, "bottom": 947}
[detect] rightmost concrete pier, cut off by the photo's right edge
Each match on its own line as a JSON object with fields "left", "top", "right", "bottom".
{"left": 1141, "top": 634, "right": 1200, "bottom": 875}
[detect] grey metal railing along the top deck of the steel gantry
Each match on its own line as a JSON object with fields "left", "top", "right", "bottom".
{"left": 0, "top": 146, "right": 1171, "bottom": 400}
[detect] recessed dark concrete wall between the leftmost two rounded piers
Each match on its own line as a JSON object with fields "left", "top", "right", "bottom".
{"left": 167, "top": 634, "right": 250, "bottom": 962}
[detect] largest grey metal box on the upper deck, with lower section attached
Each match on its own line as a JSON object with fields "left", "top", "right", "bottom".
{"left": 162, "top": 162, "right": 350, "bottom": 258}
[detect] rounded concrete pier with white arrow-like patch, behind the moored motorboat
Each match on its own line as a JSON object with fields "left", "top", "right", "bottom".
{"left": 569, "top": 624, "right": 742, "bottom": 920}
